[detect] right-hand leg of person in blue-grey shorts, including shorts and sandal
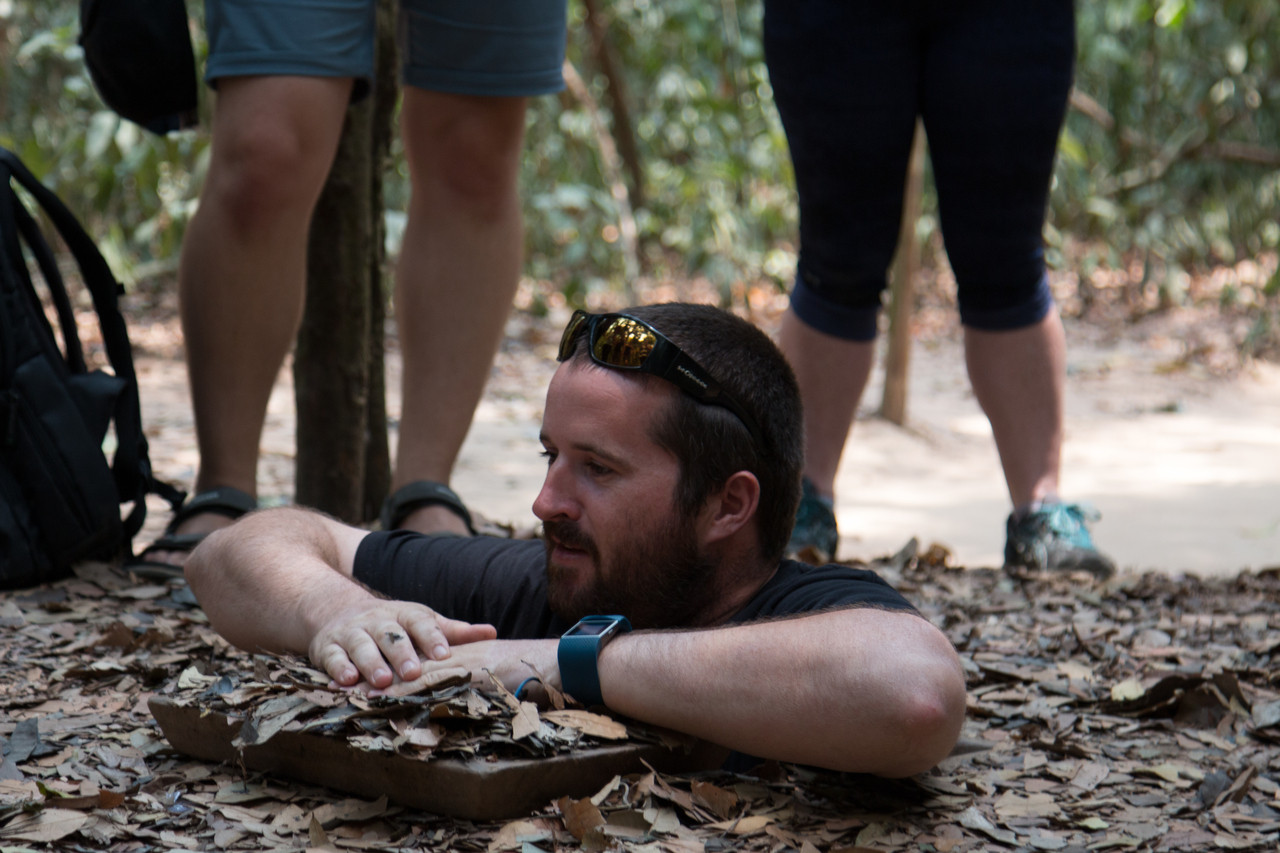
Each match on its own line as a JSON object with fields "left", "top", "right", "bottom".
{"left": 383, "top": 0, "right": 566, "bottom": 533}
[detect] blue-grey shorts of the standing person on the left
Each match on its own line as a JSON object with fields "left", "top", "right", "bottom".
{"left": 205, "top": 0, "right": 566, "bottom": 96}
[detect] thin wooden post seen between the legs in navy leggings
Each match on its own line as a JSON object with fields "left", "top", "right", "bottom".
{"left": 881, "top": 122, "right": 924, "bottom": 427}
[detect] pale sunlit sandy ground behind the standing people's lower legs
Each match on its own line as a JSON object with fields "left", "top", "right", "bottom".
{"left": 138, "top": 302, "right": 1280, "bottom": 575}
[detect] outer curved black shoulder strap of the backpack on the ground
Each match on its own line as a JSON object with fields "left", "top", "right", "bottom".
{"left": 0, "top": 147, "right": 183, "bottom": 539}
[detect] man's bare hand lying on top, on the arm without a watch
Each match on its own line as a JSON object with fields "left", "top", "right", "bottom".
{"left": 307, "top": 598, "right": 497, "bottom": 689}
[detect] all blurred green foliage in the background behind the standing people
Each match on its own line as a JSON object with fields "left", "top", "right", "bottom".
{"left": 0, "top": 0, "right": 1280, "bottom": 325}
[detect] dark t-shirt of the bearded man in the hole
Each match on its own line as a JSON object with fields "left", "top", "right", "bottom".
{"left": 355, "top": 530, "right": 914, "bottom": 639}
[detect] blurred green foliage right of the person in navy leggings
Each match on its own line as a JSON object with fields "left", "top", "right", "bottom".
{"left": 1052, "top": 0, "right": 1280, "bottom": 288}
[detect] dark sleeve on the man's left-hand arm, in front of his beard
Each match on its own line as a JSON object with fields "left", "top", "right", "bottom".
{"left": 355, "top": 530, "right": 568, "bottom": 639}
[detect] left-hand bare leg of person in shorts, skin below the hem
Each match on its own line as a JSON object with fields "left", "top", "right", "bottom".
{"left": 170, "top": 77, "right": 351, "bottom": 537}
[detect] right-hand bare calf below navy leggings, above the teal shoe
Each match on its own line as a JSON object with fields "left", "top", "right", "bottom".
{"left": 964, "top": 309, "right": 1066, "bottom": 510}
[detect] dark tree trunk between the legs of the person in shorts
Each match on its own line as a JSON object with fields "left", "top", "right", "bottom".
{"left": 293, "top": 0, "right": 396, "bottom": 524}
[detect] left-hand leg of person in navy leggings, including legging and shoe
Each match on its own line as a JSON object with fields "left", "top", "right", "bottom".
{"left": 764, "top": 0, "right": 919, "bottom": 557}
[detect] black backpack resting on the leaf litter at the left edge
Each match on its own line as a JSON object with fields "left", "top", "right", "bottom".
{"left": 0, "top": 149, "right": 183, "bottom": 589}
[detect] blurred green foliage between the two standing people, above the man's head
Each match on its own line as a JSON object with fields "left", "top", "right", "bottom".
{"left": 524, "top": 0, "right": 795, "bottom": 301}
